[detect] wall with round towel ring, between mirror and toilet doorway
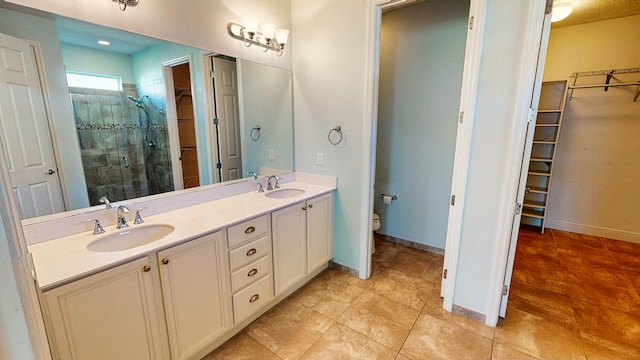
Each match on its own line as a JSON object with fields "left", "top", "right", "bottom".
{"left": 292, "top": 0, "right": 373, "bottom": 275}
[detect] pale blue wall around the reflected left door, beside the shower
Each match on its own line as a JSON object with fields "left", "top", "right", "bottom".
{"left": 0, "top": 8, "right": 89, "bottom": 209}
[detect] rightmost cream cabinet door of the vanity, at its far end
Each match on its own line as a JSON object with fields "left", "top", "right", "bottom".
{"left": 307, "top": 194, "right": 333, "bottom": 273}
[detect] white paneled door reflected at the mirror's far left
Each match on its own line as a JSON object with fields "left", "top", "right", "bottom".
{"left": 0, "top": 34, "right": 64, "bottom": 219}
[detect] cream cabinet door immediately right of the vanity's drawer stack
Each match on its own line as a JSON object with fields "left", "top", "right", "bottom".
{"left": 271, "top": 202, "right": 307, "bottom": 296}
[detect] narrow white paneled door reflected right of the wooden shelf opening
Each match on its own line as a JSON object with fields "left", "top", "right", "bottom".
{"left": 213, "top": 57, "right": 242, "bottom": 181}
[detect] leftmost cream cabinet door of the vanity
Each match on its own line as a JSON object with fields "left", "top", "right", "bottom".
{"left": 43, "top": 258, "right": 164, "bottom": 360}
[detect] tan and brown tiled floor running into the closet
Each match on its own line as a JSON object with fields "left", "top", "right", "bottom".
{"left": 204, "top": 230, "right": 640, "bottom": 360}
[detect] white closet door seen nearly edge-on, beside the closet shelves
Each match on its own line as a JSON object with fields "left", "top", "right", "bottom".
{"left": 500, "top": 9, "right": 551, "bottom": 317}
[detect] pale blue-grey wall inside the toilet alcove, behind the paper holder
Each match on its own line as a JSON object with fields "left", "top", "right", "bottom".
{"left": 374, "top": 0, "right": 469, "bottom": 249}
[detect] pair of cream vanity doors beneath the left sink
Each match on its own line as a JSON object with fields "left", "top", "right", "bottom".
{"left": 43, "top": 231, "right": 232, "bottom": 360}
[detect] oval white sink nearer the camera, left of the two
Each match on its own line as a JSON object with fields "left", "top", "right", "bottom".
{"left": 87, "top": 224, "right": 175, "bottom": 252}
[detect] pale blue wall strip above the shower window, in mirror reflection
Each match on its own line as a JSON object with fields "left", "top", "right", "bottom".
{"left": 60, "top": 43, "right": 135, "bottom": 84}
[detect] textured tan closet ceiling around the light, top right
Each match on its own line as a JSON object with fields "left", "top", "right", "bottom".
{"left": 552, "top": 0, "right": 640, "bottom": 29}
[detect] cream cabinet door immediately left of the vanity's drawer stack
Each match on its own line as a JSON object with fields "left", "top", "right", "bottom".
{"left": 158, "top": 232, "right": 231, "bottom": 359}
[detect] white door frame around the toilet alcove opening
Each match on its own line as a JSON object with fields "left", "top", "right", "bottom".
{"left": 359, "top": 0, "right": 487, "bottom": 311}
